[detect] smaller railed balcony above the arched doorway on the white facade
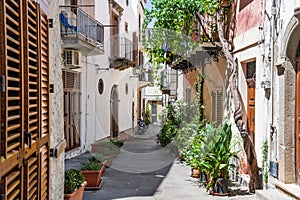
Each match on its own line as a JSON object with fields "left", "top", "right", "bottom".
{"left": 110, "top": 35, "right": 137, "bottom": 70}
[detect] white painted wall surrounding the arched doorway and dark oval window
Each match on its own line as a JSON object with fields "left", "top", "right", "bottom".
{"left": 60, "top": 0, "right": 143, "bottom": 157}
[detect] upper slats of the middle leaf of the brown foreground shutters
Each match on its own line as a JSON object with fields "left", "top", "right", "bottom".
{"left": 24, "top": 1, "right": 40, "bottom": 143}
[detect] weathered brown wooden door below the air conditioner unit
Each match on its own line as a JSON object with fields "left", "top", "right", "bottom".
{"left": 62, "top": 70, "right": 81, "bottom": 151}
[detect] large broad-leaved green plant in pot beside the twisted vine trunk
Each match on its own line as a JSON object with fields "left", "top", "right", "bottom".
{"left": 200, "top": 121, "right": 238, "bottom": 196}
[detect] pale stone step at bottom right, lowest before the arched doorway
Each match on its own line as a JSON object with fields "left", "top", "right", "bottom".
{"left": 255, "top": 189, "right": 294, "bottom": 200}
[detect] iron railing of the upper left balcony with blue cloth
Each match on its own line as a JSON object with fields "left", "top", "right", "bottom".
{"left": 59, "top": 6, "right": 104, "bottom": 46}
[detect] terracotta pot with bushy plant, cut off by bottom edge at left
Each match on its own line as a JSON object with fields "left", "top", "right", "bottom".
{"left": 64, "top": 169, "right": 87, "bottom": 200}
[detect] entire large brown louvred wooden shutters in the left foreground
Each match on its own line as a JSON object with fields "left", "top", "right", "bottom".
{"left": 0, "top": 0, "right": 50, "bottom": 199}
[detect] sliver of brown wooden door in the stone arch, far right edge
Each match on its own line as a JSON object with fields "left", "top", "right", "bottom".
{"left": 295, "top": 57, "right": 300, "bottom": 184}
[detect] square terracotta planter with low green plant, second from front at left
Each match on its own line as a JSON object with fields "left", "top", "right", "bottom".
{"left": 81, "top": 157, "right": 106, "bottom": 189}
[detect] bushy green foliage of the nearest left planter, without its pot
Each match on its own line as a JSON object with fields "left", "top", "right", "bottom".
{"left": 64, "top": 169, "right": 84, "bottom": 194}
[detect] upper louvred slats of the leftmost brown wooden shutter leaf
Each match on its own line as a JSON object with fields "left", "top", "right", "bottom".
{"left": 1, "top": 0, "right": 24, "bottom": 158}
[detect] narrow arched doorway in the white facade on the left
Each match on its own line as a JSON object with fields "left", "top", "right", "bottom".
{"left": 110, "top": 85, "right": 119, "bottom": 137}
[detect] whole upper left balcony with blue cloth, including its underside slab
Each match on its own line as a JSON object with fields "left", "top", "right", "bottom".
{"left": 59, "top": 6, "right": 104, "bottom": 56}
